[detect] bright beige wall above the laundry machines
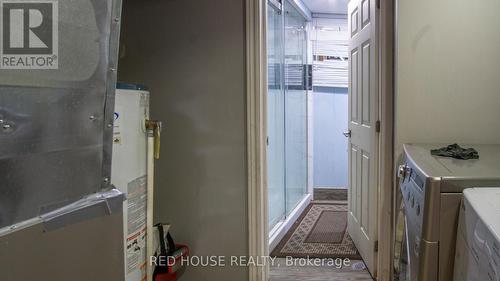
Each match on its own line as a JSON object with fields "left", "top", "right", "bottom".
{"left": 395, "top": 0, "right": 500, "bottom": 151}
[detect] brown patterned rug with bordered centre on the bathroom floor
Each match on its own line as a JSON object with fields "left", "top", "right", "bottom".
{"left": 271, "top": 203, "right": 361, "bottom": 260}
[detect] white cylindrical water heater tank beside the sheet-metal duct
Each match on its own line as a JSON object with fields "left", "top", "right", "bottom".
{"left": 111, "top": 83, "right": 149, "bottom": 281}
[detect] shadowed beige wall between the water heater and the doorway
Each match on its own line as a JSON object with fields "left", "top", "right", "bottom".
{"left": 119, "top": 0, "right": 248, "bottom": 281}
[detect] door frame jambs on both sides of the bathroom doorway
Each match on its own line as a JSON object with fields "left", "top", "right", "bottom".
{"left": 245, "top": 0, "right": 395, "bottom": 281}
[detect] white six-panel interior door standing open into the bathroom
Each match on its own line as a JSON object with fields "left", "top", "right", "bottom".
{"left": 346, "top": 0, "right": 379, "bottom": 276}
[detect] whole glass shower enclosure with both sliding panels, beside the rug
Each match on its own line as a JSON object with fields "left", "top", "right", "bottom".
{"left": 267, "top": 0, "right": 307, "bottom": 236}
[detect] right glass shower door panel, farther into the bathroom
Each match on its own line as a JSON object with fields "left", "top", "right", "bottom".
{"left": 284, "top": 1, "right": 307, "bottom": 215}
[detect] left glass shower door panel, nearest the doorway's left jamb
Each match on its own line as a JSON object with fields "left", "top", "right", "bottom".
{"left": 267, "top": 5, "right": 286, "bottom": 229}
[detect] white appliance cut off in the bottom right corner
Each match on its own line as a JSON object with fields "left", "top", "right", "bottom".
{"left": 453, "top": 188, "right": 500, "bottom": 281}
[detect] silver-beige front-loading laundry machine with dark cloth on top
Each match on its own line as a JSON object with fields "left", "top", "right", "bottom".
{"left": 393, "top": 144, "right": 500, "bottom": 281}
